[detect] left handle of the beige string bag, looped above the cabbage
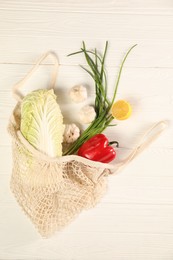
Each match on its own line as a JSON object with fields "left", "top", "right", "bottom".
{"left": 12, "top": 51, "right": 59, "bottom": 102}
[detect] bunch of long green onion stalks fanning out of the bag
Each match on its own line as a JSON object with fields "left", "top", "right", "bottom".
{"left": 63, "top": 42, "right": 136, "bottom": 155}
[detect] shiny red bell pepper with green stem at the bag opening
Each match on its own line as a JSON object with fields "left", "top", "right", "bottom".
{"left": 78, "top": 134, "right": 118, "bottom": 163}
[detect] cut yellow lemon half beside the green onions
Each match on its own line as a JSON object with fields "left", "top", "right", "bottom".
{"left": 111, "top": 100, "right": 132, "bottom": 120}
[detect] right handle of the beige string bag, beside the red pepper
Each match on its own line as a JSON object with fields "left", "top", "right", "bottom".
{"left": 115, "top": 121, "right": 168, "bottom": 173}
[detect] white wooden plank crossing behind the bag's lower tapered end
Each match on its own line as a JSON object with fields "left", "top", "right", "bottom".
{"left": 0, "top": 202, "right": 173, "bottom": 234}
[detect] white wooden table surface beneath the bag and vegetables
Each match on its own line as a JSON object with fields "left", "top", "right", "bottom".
{"left": 0, "top": 0, "right": 173, "bottom": 260}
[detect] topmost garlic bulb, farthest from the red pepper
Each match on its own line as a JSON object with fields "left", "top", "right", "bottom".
{"left": 69, "top": 85, "right": 87, "bottom": 103}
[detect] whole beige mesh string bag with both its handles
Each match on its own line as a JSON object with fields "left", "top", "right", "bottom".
{"left": 8, "top": 52, "right": 166, "bottom": 237}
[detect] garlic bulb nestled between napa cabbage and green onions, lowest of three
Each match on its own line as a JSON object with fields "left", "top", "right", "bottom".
{"left": 63, "top": 124, "right": 80, "bottom": 144}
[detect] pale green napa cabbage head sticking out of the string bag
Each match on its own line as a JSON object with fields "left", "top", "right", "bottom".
{"left": 21, "top": 90, "right": 64, "bottom": 157}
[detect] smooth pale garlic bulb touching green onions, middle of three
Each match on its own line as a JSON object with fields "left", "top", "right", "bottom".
{"left": 79, "top": 106, "right": 96, "bottom": 124}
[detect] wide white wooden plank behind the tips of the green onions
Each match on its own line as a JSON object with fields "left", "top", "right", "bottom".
{"left": 0, "top": 11, "right": 173, "bottom": 67}
